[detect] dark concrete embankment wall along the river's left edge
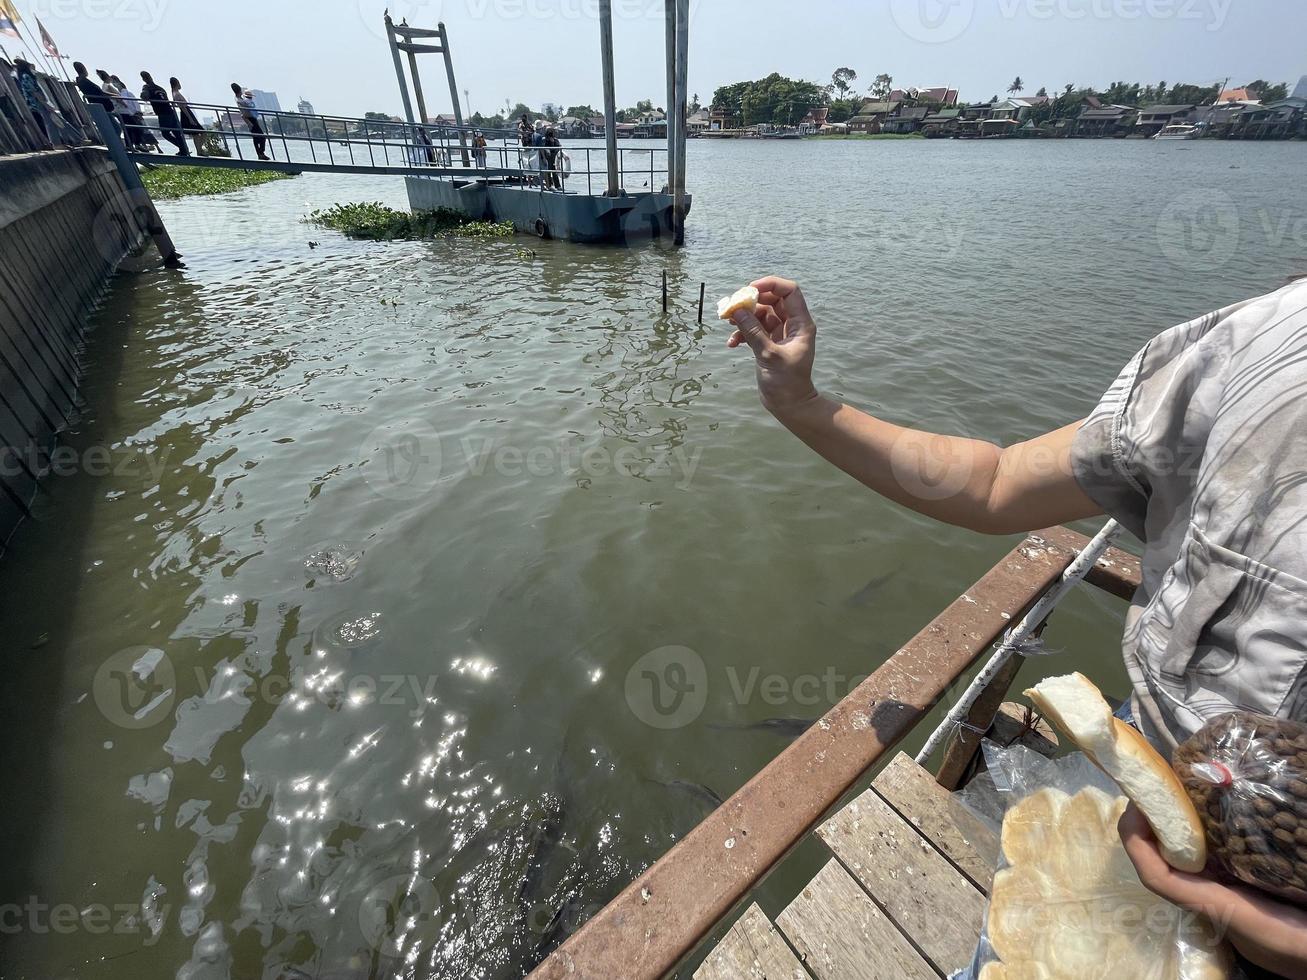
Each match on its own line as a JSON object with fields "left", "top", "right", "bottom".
{"left": 0, "top": 148, "right": 142, "bottom": 556}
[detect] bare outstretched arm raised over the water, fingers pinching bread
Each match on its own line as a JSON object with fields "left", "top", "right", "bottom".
{"left": 727, "top": 277, "right": 1102, "bottom": 534}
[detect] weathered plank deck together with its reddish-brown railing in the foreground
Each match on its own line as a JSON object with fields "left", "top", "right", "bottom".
{"left": 531, "top": 528, "right": 1140, "bottom": 980}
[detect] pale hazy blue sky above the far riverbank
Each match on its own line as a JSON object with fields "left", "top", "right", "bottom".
{"left": 10, "top": 0, "right": 1307, "bottom": 115}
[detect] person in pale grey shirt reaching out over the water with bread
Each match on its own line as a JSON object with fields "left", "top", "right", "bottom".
{"left": 727, "top": 276, "right": 1307, "bottom": 977}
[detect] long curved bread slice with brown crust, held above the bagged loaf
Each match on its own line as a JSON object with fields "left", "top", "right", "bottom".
{"left": 1026, "top": 673, "right": 1208, "bottom": 872}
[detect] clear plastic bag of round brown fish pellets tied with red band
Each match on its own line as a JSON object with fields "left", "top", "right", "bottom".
{"left": 1172, "top": 712, "right": 1307, "bottom": 906}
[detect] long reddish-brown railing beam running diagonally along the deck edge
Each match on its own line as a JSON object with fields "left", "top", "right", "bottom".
{"left": 531, "top": 529, "right": 1084, "bottom": 980}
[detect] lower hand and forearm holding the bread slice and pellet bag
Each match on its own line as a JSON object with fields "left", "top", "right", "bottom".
{"left": 1117, "top": 805, "right": 1307, "bottom": 980}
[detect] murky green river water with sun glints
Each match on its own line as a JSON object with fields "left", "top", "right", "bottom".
{"left": 0, "top": 141, "right": 1307, "bottom": 979}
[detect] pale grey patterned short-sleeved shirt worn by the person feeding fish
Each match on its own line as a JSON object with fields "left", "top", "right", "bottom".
{"left": 1072, "top": 281, "right": 1307, "bottom": 745}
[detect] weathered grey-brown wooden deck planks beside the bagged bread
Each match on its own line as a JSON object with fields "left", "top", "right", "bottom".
{"left": 694, "top": 754, "right": 999, "bottom": 980}
